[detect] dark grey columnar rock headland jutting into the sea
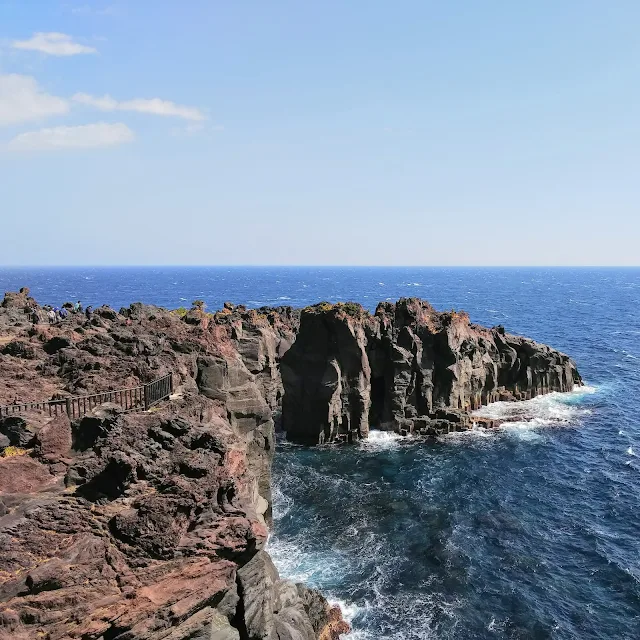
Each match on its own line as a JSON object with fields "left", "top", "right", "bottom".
{"left": 281, "top": 298, "right": 581, "bottom": 444}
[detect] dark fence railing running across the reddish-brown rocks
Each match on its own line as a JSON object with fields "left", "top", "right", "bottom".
{"left": 0, "top": 373, "right": 173, "bottom": 419}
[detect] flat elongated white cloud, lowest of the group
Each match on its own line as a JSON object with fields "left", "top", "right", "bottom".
{"left": 7, "top": 122, "right": 135, "bottom": 151}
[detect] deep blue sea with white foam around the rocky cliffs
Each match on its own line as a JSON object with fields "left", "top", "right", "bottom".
{"left": 0, "top": 268, "right": 640, "bottom": 639}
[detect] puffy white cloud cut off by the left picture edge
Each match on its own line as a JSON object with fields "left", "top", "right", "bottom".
{"left": 0, "top": 73, "right": 69, "bottom": 126}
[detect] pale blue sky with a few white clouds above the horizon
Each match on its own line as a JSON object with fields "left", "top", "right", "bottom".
{"left": 0, "top": 0, "right": 640, "bottom": 266}
